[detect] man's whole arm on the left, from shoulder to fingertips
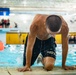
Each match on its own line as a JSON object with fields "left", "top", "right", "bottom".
{"left": 18, "top": 18, "right": 37, "bottom": 72}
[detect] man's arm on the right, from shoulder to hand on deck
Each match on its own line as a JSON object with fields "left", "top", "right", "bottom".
{"left": 62, "top": 23, "right": 74, "bottom": 70}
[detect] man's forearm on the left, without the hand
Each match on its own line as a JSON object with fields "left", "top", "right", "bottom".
{"left": 26, "top": 33, "right": 36, "bottom": 67}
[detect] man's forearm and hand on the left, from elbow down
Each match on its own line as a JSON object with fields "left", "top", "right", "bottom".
{"left": 18, "top": 33, "right": 36, "bottom": 72}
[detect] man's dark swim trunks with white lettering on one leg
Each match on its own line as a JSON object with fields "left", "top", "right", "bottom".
{"left": 23, "top": 36, "right": 56, "bottom": 66}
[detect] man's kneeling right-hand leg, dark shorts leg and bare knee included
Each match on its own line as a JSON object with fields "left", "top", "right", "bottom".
{"left": 41, "top": 37, "right": 56, "bottom": 71}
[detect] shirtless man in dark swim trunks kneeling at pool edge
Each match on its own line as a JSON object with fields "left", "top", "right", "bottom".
{"left": 18, "top": 14, "right": 74, "bottom": 72}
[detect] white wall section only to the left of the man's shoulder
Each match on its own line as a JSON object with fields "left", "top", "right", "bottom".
{"left": 0, "top": 14, "right": 35, "bottom": 32}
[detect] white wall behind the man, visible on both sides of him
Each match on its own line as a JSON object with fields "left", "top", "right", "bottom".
{"left": 0, "top": 14, "right": 76, "bottom": 32}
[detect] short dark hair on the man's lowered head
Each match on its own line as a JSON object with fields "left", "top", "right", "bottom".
{"left": 46, "top": 15, "right": 62, "bottom": 32}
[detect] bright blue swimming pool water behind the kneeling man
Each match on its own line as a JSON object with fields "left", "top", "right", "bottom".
{"left": 0, "top": 44, "right": 76, "bottom": 67}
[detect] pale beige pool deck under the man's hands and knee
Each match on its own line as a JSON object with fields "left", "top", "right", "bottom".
{"left": 0, "top": 67, "right": 76, "bottom": 75}
